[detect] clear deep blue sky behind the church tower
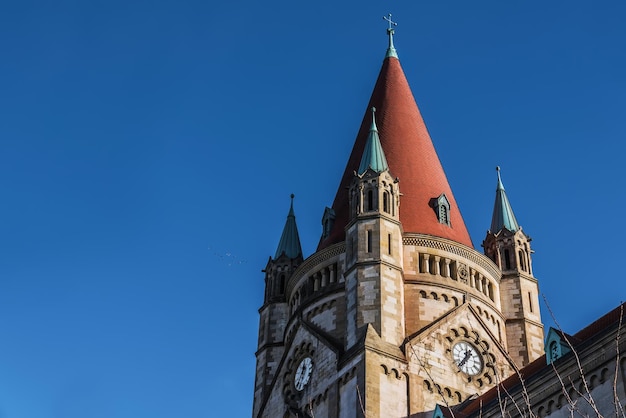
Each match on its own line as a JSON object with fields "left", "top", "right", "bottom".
{"left": 0, "top": 0, "right": 626, "bottom": 418}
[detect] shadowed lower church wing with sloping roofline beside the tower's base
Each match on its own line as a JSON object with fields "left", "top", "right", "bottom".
{"left": 435, "top": 304, "right": 626, "bottom": 418}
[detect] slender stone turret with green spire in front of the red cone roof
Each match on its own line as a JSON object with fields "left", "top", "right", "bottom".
{"left": 346, "top": 108, "right": 404, "bottom": 348}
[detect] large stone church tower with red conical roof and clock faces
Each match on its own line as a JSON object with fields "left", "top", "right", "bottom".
{"left": 253, "top": 19, "right": 543, "bottom": 418}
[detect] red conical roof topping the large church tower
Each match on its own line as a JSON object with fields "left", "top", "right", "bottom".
{"left": 318, "top": 57, "right": 473, "bottom": 249}
